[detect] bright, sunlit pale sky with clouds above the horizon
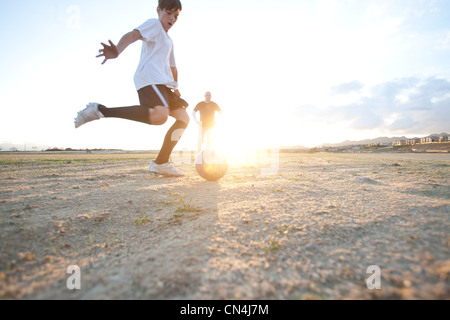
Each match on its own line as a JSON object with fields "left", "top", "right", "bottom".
{"left": 0, "top": 0, "right": 450, "bottom": 150}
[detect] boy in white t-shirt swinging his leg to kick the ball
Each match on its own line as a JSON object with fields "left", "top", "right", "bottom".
{"left": 75, "top": 0, "right": 189, "bottom": 176}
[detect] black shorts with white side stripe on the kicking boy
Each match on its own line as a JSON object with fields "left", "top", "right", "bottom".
{"left": 138, "top": 84, "right": 189, "bottom": 110}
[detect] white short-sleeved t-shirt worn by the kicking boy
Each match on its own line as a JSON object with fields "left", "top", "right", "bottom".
{"left": 134, "top": 19, "right": 178, "bottom": 90}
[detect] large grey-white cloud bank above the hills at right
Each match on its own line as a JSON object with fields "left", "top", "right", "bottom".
{"left": 297, "top": 77, "right": 450, "bottom": 135}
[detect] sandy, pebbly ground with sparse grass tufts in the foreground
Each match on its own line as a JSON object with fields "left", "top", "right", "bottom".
{"left": 0, "top": 154, "right": 450, "bottom": 299}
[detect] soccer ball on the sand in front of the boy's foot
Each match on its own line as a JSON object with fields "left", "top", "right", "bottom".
{"left": 195, "top": 150, "right": 228, "bottom": 181}
